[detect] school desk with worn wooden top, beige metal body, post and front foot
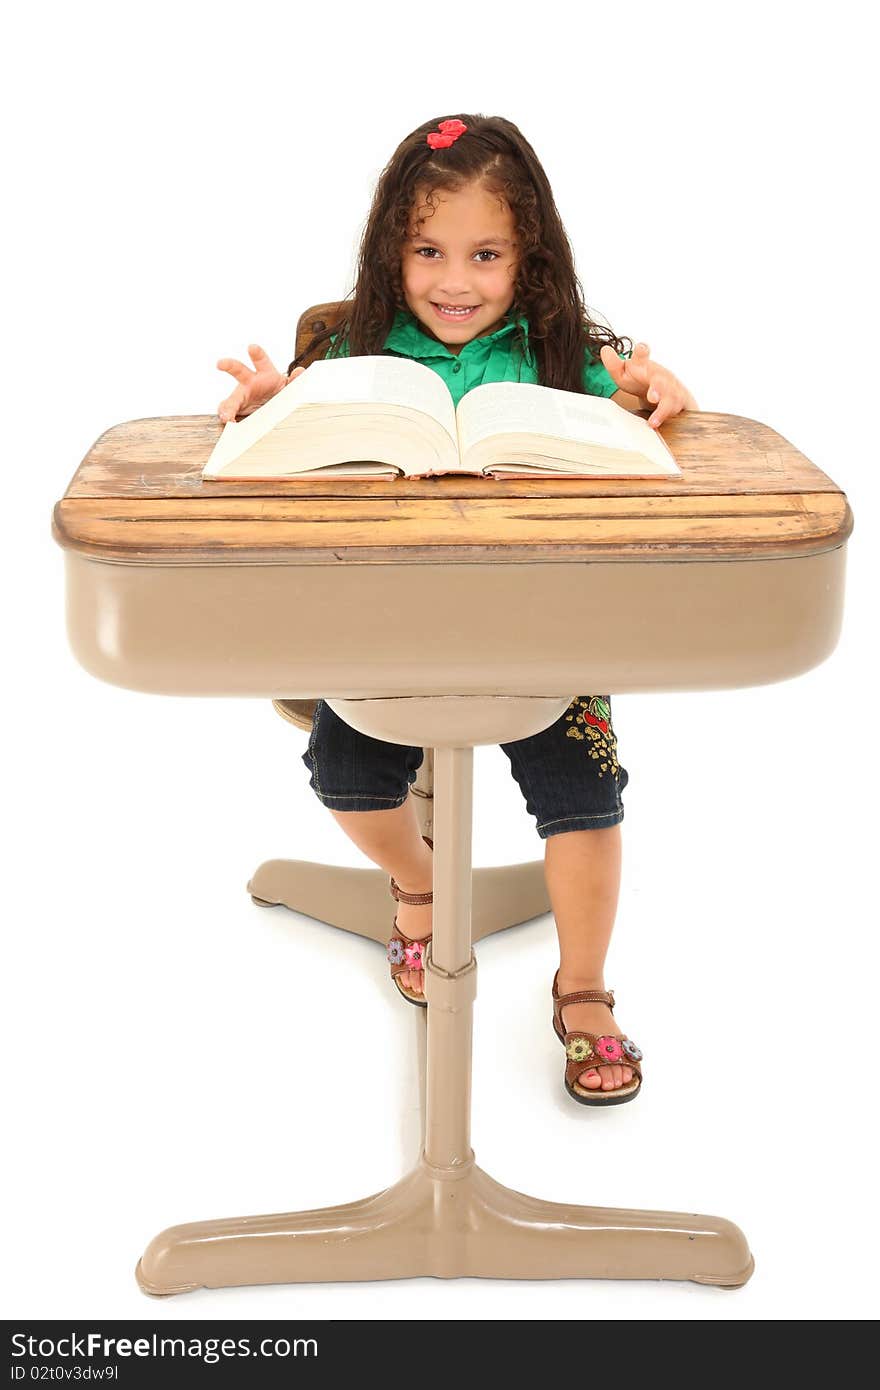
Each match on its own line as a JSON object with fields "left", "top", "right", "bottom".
{"left": 54, "top": 389, "right": 852, "bottom": 1294}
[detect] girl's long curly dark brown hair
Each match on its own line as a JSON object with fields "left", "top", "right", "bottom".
{"left": 288, "top": 111, "right": 633, "bottom": 395}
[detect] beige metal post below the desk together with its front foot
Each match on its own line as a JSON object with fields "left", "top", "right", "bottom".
{"left": 136, "top": 706, "right": 755, "bottom": 1294}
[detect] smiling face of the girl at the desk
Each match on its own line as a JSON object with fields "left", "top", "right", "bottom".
{"left": 400, "top": 183, "right": 517, "bottom": 353}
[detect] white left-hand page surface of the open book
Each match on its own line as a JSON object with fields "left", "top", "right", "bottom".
{"left": 203, "top": 356, "right": 459, "bottom": 474}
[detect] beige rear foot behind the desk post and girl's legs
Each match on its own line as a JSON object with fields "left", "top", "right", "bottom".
{"left": 247, "top": 859, "right": 551, "bottom": 945}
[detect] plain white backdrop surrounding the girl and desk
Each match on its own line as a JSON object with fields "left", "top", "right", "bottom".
{"left": 3, "top": 0, "right": 880, "bottom": 1323}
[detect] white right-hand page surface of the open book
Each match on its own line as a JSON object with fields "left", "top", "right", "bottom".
{"left": 457, "top": 381, "right": 681, "bottom": 474}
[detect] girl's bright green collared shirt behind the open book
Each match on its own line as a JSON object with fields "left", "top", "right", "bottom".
{"left": 328, "top": 309, "right": 619, "bottom": 406}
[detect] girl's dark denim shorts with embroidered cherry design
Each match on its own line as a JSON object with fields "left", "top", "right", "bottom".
{"left": 303, "top": 695, "right": 630, "bottom": 840}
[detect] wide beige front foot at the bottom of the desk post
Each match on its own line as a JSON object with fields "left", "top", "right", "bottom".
{"left": 136, "top": 1151, "right": 755, "bottom": 1295}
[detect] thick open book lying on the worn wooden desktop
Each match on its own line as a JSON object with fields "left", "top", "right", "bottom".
{"left": 202, "top": 356, "right": 681, "bottom": 480}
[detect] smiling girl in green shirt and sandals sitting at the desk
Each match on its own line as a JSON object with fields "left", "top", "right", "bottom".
{"left": 217, "top": 114, "right": 698, "bottom": 1105}
